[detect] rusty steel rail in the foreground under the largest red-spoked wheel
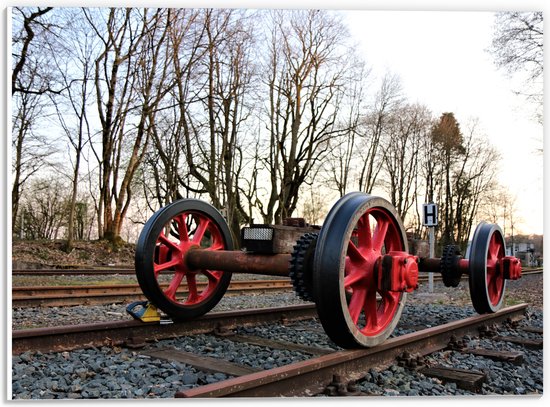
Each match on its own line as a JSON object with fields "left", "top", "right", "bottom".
{"left": 176, "top": 304, "right": 528, "bottom": 398}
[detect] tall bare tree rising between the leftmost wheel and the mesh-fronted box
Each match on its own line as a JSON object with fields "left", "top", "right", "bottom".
{"left": 198, "top": 10, "right": 254, "bottom": 241}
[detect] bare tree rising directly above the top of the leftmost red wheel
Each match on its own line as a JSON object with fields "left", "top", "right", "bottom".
{"left": 141, "top": 9, "right": 206, "bottom": 210}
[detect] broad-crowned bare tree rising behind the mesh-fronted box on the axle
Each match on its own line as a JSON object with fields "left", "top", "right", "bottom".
{"left": 262, "top": 10, "right": 350, "bottom": 222}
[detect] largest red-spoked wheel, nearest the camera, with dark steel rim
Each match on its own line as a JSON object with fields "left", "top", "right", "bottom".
{"left": 313, "top": 192, "right": 407, "bottom": 348}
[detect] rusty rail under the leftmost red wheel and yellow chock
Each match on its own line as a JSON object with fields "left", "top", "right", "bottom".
{"left": 12, "top": 304, "right": 317, "bottom": 354}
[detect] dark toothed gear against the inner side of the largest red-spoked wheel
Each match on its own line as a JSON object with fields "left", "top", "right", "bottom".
{"left": 288, "top": 233, "right": 318, "bottom": 301}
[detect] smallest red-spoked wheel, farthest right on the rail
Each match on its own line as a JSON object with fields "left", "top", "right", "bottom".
{"left": 468, "top": 222, "right": 506, "bottom": 314}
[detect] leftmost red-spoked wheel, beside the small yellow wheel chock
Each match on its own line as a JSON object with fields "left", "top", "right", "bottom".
{"left": 135, "top": 199, "right": 233, "bottom": 320}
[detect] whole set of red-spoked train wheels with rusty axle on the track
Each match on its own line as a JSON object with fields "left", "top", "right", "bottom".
{"left": 135, "top": 192, "right": 521, "bottom": 348}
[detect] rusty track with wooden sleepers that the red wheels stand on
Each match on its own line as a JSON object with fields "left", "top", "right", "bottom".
{"left": 12, "top": 304, "right": 542, "bottom": 398}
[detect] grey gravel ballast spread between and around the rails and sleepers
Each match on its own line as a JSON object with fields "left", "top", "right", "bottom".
{"left": 12, "top": 277, "right": 543, "bottom": 399}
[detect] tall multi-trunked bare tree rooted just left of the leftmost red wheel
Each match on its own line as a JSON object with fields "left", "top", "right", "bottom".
{"left": 85, "top": 8, "right": 168, "bottom": 244}
